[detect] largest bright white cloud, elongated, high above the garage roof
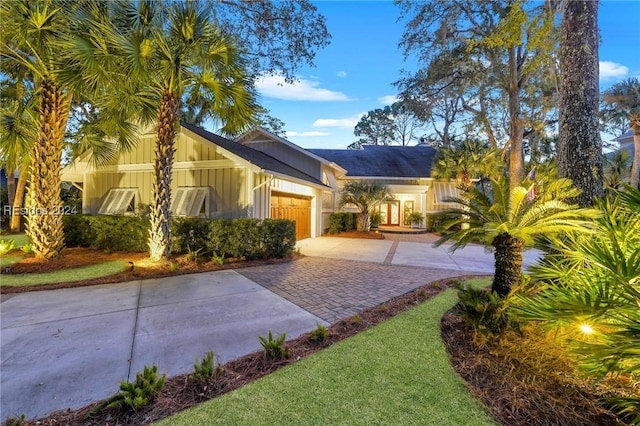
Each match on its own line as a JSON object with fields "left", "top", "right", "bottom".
{"left": 256, "top": 75, "right": 349, "bottom": 102}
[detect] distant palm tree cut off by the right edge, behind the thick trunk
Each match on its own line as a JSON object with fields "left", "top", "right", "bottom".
{"left": 602, "top": 78, "right": 640, "bottom": 188}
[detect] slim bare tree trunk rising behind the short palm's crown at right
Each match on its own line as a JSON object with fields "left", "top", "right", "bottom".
{"left": 507, "top": 46, "right": 524, "bottom": 189}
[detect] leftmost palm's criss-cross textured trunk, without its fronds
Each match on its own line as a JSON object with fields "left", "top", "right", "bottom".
{"left": 27, "top": 79, "right": 69, "bottom": 260}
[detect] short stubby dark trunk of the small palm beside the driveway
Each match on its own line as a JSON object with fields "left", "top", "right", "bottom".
{"left": 491, "top": 232, "right": 524, "bottom": 298}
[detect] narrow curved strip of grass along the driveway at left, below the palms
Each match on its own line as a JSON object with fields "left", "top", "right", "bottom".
{"left": 2, "top": 260, "right": 128, "bottom": 287}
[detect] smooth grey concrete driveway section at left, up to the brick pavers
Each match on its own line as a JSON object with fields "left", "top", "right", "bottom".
{"left": 0, "top": 271, "right": 327, "bottom": 420}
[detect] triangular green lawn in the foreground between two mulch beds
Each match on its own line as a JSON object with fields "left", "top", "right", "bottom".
{"left": 159, "top": 280, "right": 496, "bottom": 426}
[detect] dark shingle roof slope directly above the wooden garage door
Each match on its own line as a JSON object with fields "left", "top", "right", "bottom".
{"left": 180, "top": 123, "right": 326, "bottom": 186}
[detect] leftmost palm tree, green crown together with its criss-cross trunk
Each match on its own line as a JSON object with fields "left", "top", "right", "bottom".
{"left": 0, "top": 0, "right": 77, "bottom": 259}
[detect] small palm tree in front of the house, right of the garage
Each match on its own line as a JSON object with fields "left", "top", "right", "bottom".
{"left": 339, "top": 182, "right": 394, "bottom": 231}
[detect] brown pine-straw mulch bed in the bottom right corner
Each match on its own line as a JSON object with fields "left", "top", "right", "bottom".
{"left": 441, "top": 308, "right": 637, "bottom": 426}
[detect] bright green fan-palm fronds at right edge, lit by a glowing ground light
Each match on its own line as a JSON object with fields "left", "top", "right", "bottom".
{"left": 516, "top": 186, "right": 640, "bottom": 421}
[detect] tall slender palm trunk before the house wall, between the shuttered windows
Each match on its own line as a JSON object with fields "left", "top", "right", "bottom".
{"left": 149, "top": 90, "right": 180, "bottom": 261}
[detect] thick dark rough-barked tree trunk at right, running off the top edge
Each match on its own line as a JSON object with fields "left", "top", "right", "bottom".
{"left": 557, "top": 0, "right": 604, "bottom": 207}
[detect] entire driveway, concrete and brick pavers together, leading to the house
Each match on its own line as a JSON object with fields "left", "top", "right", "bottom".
{"left": 0, "top": 234, "right": 534, "bottom": 420}
